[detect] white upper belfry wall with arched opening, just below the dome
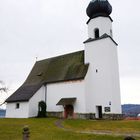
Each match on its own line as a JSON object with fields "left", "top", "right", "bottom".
{"left": 88, "top": 17, "right": 112, "bottom": 38}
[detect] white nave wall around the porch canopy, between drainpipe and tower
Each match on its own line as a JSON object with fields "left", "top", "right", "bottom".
{"left": 47, "top": 80, "right": 85, "bottom": 113}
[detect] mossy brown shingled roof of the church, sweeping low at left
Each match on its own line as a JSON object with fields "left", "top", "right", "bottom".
{"left": 6, "top": 51, "right": 88, "bottom": 102}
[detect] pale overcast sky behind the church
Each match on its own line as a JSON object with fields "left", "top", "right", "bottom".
{"left": 0, "top": 0, "right": 140, "bottom": 103}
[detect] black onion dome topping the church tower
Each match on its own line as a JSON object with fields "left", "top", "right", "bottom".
{"left": 86, "top": 0, "right": 112, "bottom": 18}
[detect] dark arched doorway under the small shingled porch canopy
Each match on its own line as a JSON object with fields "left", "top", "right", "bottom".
{"left": 64, "top": 105, "right": 74, "bottom": 118}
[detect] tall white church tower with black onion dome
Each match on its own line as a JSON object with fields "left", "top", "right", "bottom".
{"left": 84, "top": 0, "right": 121, "bottom": 118}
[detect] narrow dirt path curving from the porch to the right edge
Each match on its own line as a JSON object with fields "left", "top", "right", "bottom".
{"left": 55, "top": 119, "right": 140, "bottom": 137}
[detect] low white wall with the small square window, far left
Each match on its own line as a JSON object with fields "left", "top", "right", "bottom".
{"left": 6, "top": 102, "right": 29, "bottom": 118}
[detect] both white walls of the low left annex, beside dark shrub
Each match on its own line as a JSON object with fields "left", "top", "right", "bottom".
{"left": 6, "top": 86, "right": 45, "bottom": 118}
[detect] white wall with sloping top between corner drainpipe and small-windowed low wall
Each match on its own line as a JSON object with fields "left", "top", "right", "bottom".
{"left": 29, "top": 86, "right": 45, "bottom": 117}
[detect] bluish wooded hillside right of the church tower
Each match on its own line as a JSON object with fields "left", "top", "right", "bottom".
{"left": 122, "top": 104, "right": 140, "bottom": 117}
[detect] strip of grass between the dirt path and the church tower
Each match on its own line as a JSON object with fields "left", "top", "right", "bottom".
{"left": 64, "top": 120, "right": 140, "bottom": 134}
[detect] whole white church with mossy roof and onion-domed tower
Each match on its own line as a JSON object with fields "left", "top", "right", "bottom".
{"left": 6, "top": 0, "right": 122, "bottom": 119}
